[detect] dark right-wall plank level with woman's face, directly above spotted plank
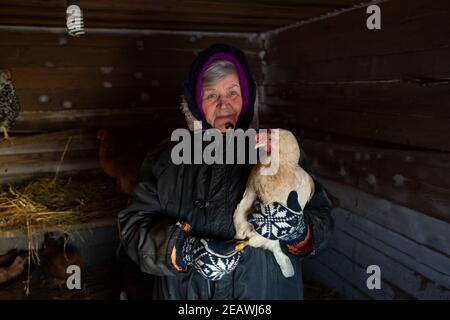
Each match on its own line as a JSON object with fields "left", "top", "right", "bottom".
{"left": 261, "top": 82, "right": 450, "bottom": 151}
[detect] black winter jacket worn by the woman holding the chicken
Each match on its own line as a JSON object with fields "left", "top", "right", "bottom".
{"left": 119, "top": 138, "right": 333, "bottom": 299}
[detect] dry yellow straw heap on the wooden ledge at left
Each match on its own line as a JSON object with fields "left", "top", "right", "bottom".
{"left": 0, "top": 175, "right": 127, "bottom": 231}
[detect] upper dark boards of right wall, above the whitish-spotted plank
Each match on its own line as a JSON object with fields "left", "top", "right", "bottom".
{"left": 263, "top": 0, "right": 450, "bottom": 151}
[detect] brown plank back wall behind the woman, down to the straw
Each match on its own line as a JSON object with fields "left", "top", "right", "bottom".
{"left": 0, "top": 28, "right": 262, "bottom": 183}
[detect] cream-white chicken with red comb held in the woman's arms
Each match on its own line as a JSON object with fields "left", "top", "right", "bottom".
{"left": 234, "top": 129, "right": 314, "bottom": 277}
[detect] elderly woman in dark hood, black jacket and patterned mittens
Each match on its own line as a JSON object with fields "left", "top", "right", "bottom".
{"left": 119, "top": 44, "right": 333, "bottom": 299}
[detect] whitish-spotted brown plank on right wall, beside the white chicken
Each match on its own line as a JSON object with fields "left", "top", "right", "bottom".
{"left": 300, "top": 139, "right": 450, "bottom": 222}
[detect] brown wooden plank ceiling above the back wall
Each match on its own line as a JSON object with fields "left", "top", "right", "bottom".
{"left": 0, "top": 0, "right": 366, "bottom": 32}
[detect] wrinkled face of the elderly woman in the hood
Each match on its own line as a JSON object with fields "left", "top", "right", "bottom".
{"left": 202, "top": 73, "right": 242, "bottom": 132}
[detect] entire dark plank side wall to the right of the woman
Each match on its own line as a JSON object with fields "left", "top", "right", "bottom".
{"left": 259, "top": 0, "right": 450, "bottom": 299}
